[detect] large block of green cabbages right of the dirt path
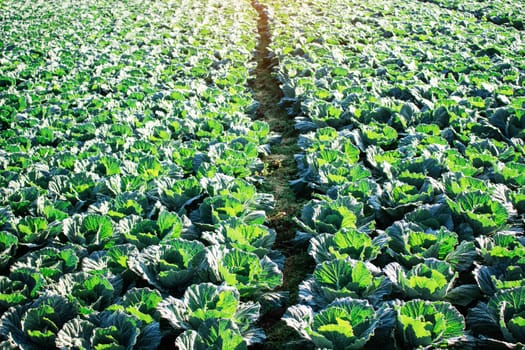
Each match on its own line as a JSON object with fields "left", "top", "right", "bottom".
{"left": 264, "top": 0, "right": 525, "bottom": 349}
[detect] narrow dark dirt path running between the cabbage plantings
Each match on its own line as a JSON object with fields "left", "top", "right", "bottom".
{"left": 251, "top": 0, "right": 314, "bottom": 349}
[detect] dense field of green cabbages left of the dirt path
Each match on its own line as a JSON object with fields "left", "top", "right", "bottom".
{"left": 0, "top": 0, "right": 284, "bottom": 349}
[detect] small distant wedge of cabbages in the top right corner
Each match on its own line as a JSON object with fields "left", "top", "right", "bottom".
{"left": 416, "top": 0, "right": 525, "bottom": 30}
